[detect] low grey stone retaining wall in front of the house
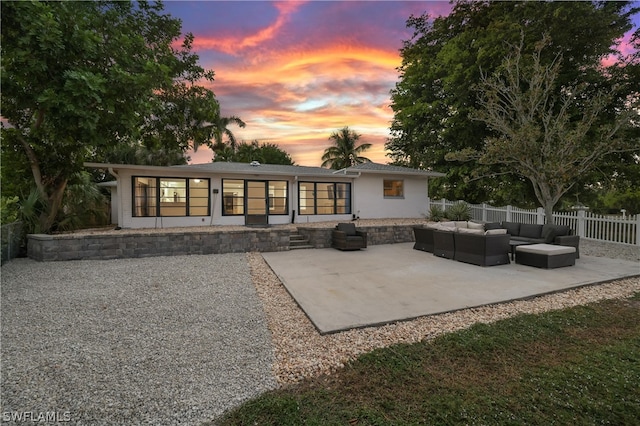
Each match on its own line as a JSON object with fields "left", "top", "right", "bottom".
{"left": 27, "top": 225, "right": 414, "bottom": 262}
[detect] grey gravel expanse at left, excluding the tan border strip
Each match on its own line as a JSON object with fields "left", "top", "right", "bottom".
{"left": 0, "top": 254, "right": 276, "bottom": 425}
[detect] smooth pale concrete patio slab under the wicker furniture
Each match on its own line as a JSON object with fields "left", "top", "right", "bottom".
{"left": 262, "top": 243, "right": 640, "bottom": 334}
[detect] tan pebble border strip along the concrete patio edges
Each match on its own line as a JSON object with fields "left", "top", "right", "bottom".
{"left": 249, "top": 241, "right": 640, "bottom": 386}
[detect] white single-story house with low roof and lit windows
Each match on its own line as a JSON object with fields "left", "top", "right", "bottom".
{"left": 85, "top": 161, "right": 444, "bottom": 228}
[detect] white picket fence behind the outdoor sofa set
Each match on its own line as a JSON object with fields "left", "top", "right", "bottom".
{"left": 427, "top": 199, "right": 640, "bottom": 246}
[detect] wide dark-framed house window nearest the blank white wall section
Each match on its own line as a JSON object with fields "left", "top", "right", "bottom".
{"left": 298, "top": 182, "right": 351, "bottom": 215}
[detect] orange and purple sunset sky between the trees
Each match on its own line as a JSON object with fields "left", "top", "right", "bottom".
{"left": 165, "top": 1, "right": 636, "bottom": 166}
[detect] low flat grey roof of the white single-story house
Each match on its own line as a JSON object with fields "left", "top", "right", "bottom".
{"left": 84, "top": 162, "right": 444, "bottom": 177}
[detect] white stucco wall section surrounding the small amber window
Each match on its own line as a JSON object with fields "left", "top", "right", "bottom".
{"left": 354, "top": 174, "right": 428, "bottom": 219}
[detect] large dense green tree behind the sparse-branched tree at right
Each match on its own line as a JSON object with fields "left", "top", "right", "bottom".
{"left": 386, "top": 1, "right": 638, "bottom": 205}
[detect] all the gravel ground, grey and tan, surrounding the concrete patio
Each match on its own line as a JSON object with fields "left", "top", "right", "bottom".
{"left": 0, "top": 241, "right": 640, "bottom": 424}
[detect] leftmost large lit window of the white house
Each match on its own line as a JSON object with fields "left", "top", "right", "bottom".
{"left": 133, "top": 176, "right": 211, "bottom": 217}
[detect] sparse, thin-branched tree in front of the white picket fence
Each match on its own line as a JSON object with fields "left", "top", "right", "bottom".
{"left": 447, "top": 38, "right": 638, "bottom": 223}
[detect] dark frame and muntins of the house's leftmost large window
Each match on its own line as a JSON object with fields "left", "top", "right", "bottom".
{"left": 131, "top": 175, "right": 211, "bottom": 218}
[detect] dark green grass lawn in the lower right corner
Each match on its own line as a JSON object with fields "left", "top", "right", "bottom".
{"left": 220, "top": 294, "right": 640, "bottom": 425}
